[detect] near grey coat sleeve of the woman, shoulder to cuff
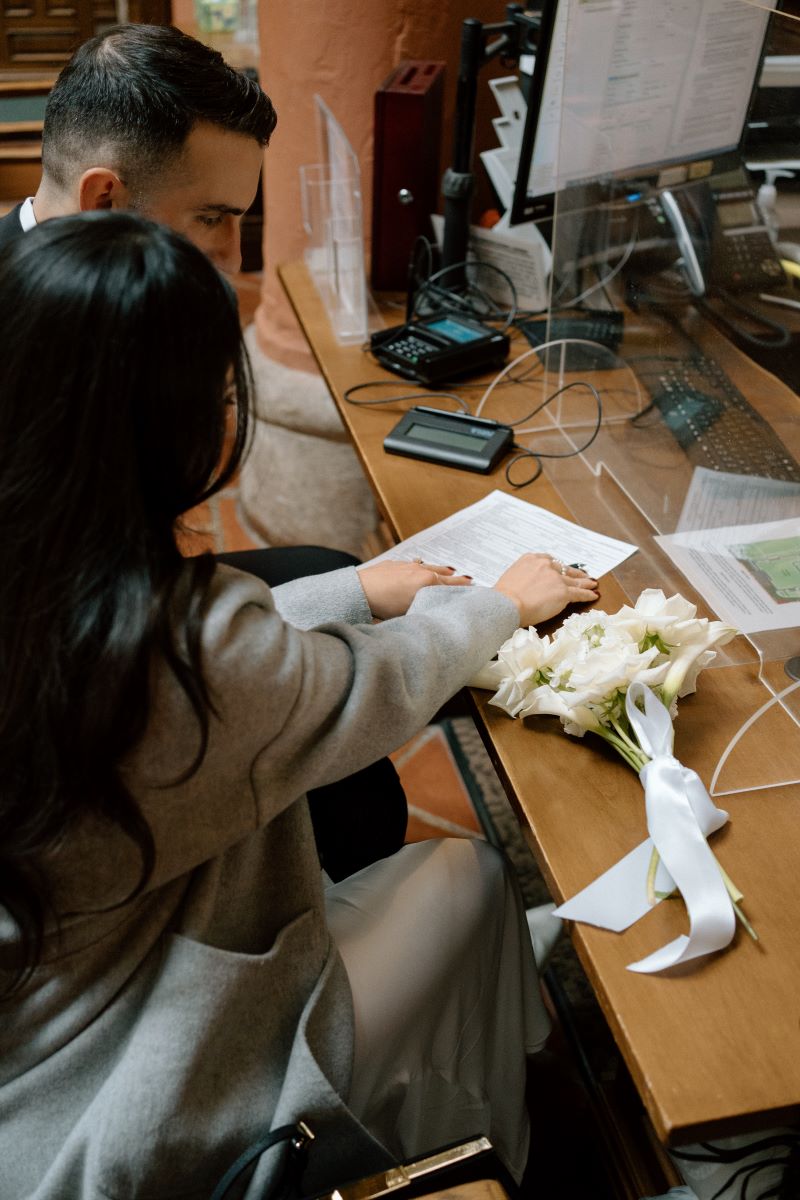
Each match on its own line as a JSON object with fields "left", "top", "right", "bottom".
{"left": 115, "top": 568, "right": 518, "bottom": 884}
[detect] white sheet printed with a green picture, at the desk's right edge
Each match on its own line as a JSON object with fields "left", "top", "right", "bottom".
{"left": 655, "top": 516, "right": 800, "bottom": 634}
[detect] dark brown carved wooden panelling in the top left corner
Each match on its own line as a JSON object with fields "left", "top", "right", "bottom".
{"left": 0, "top": 0, "right": 170, "bottom": 79}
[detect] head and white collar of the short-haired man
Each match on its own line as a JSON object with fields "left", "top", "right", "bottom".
{"left": 0, "top": 25, "right": 277, "bottom": 272}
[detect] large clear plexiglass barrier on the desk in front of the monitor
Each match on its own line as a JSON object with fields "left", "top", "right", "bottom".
{"left": 521, "top": 0, "right": 800, "bottom": 794}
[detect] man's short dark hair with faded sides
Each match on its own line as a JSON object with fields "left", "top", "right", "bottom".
{"left": 42, "top": 25, "right": 277, "bottom": 191}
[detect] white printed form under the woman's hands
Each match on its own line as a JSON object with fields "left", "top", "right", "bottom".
{"left": 372, "top": 491, "right": 637, "bottom": 587}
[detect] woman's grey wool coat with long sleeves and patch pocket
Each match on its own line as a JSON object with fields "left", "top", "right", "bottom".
{"left": 0, "top": 568, "right": 517, "bottom": 1200}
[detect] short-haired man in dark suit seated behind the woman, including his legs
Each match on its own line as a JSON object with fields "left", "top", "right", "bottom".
{"left": 0, "top": 25, "right": 408, "bottom": 880}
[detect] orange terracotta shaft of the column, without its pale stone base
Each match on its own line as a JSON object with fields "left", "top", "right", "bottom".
{"left": 255, "top": 0, "right": 505, "bottom": 371}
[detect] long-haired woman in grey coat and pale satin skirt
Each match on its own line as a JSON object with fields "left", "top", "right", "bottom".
{"left": 0, "top": 214, "right": 596, "bottom": 1200}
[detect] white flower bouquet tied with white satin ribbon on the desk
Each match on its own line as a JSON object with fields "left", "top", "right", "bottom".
{"left": 471, "top": 589, "right": 756, "bottom": 971}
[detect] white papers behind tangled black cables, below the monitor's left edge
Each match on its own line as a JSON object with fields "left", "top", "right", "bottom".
{"left": 431, "top": 212, "right": 552, "bottom": 312}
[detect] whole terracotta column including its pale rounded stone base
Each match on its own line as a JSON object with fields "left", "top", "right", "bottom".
{"left": 240, "top": 0, "right": 505, "bottom": 557}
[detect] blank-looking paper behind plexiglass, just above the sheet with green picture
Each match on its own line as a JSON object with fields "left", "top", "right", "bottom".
{"left": 675, "top": 467, "right": 800, "bottom": 533}
